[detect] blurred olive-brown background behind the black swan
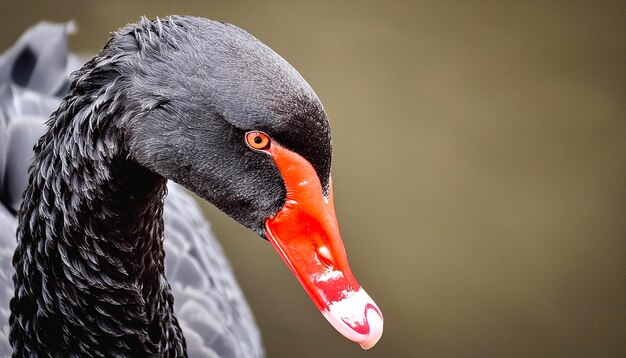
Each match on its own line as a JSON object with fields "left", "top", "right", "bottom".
{"left": 0, "top": 1, "right": 626, "bottom": 357}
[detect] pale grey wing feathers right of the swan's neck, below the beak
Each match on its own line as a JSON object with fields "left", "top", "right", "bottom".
{"left": 164, "top": 183, "right": 263, "bottom": 357}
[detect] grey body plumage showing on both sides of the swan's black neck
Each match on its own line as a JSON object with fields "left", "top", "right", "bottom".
{"left": 0, "top": 23, "right": 263, "bottom": 358}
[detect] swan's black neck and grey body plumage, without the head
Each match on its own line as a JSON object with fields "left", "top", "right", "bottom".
{"left": 0, "top": 18, "right": 262, "bottom": 357}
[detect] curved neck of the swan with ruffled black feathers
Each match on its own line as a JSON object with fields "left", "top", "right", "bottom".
{"left": 10, "top": 79, "right": 185, "bottom": 357}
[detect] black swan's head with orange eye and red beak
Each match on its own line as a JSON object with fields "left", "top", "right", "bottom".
{"left": 95, "top": 17, "right": 383, "bottom": 348}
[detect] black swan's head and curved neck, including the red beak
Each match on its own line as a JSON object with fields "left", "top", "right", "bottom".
{"left": 0, "top": 16, "right": 383, "bottom": 357}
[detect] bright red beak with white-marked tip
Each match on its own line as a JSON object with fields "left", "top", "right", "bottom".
{"left": 264, "top": 142, "right": 383, "bottom": 349}
